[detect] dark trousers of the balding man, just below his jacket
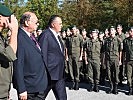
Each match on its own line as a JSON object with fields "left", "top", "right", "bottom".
{"left": 18, "top": 92, "right": 45, "bottom": 100}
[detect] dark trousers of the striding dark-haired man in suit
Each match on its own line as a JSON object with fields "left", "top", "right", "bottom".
{"left": 44, "top": 79, "right": 67, "bottom": 100}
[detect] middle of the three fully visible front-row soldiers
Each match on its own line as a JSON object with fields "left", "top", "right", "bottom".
{"left": 85, "top": 29, "right": 101, "bottom": 92}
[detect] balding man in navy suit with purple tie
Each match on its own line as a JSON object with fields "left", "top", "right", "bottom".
{"left": 13, "top": 12, "right": 48, "bottom": 100}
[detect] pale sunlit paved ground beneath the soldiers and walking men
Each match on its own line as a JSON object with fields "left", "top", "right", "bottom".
{"left": 11, "top": 83, "right": 133, "bottom": 100}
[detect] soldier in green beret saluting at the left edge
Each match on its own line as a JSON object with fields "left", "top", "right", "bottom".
{"left": 0, "top": 4, "right": 18, "bottom": 100}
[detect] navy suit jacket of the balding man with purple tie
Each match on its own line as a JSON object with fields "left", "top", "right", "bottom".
{"left": 13, "top": 28, "right": 48, "bottom": 93}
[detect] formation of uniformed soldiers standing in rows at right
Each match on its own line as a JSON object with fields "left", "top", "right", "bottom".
{"left": 61, "top": 24, "right": 133, "bottom": 95}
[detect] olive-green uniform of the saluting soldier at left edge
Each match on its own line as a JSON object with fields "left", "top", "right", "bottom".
{"left": 0, "top": 33, "right": 16, "bottom": 98}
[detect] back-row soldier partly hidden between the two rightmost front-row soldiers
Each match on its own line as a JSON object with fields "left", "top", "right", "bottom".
{"left": 116, "top": 24, "right": 125, "bottom": 86}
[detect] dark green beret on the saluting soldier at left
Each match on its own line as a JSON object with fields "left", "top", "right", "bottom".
{"left": 0, "top": 4, "right": 12, "bottom": 17}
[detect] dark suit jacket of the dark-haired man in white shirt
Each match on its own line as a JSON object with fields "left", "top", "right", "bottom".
{"left": 39, "top": 29, "right": 64, "bottom": 80}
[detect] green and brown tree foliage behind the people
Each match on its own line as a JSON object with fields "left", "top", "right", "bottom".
{"left": 2, "top": 0, "right": 133, "bottom": 30}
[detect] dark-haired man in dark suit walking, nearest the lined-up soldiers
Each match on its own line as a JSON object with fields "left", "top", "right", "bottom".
{"left": 39, "top": 15, "right": 67, "bottom": 100}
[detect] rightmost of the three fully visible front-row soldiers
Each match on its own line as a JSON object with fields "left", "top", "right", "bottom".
{"left": 105, "top": 26, "right": 122, "bottom": 94}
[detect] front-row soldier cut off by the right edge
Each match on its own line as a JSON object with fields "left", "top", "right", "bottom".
{"left": 123, "top": 27, "right": 133, "bottom": 95}
